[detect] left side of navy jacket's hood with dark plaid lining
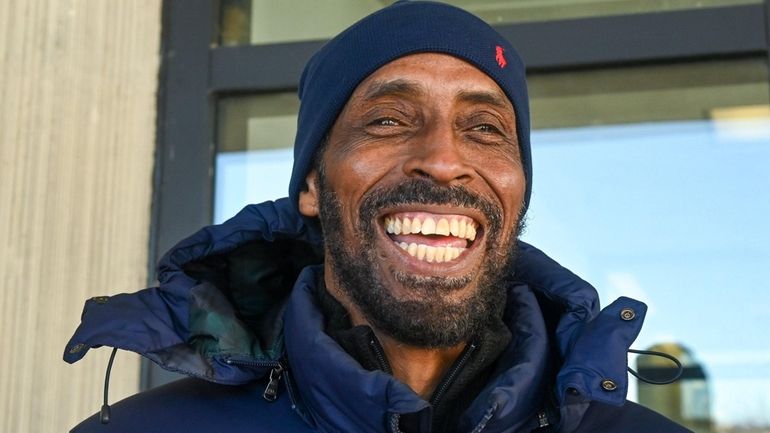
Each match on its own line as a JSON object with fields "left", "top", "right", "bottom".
{"left": 64, "top": 199, "right": 322, "bottom": 384}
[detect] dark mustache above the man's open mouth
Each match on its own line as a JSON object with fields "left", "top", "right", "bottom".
{"left": 359, "top": 178, "right": 502, "bottom": 232}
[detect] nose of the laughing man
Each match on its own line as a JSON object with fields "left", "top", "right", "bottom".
{"left": 403, "top": 127, "right": 473, "bottom": 185}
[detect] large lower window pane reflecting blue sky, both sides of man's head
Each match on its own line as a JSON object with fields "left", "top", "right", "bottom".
{"left": 215, "top": 58, "right": 770, "bottom": 432}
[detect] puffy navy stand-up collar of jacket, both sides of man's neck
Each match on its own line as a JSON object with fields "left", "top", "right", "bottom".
{"left": 284, "top": 268, "right": 552, "bottom": 432}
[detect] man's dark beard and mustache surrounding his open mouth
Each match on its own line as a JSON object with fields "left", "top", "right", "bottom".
{"left": 318, "top": 176, "right": 521, "bottom": 348}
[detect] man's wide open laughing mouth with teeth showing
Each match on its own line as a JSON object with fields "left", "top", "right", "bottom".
{"left": 383, "top": 212, "right": 479, "bottom": 263}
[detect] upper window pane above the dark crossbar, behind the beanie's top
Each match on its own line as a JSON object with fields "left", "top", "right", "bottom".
{"left": 220, "top": 0, "right": 762, "bottom": 45}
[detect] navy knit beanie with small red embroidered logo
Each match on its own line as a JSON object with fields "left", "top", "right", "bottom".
{"left": 289, "top": 1, "right": 532, "bottom": 210}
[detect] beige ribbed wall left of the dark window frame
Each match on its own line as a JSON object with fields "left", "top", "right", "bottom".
{"left": 0, "top": 0, "right": 161, "bottom": 432}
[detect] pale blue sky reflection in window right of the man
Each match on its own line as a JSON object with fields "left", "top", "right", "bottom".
{"left": 524, "top": 116, "right": 770, "bottom": 432}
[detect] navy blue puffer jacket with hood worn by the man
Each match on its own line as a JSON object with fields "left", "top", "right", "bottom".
{"left": 64, "top": 199, "right": 687, "bottom": 433}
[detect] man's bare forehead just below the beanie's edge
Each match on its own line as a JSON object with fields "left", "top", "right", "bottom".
{"left": 350, "top": 53, "right": 513, "bottom": 110}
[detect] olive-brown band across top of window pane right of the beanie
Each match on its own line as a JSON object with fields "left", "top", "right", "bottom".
{"left": 528, "top": 57, "right": 770, "bottom": 129}
